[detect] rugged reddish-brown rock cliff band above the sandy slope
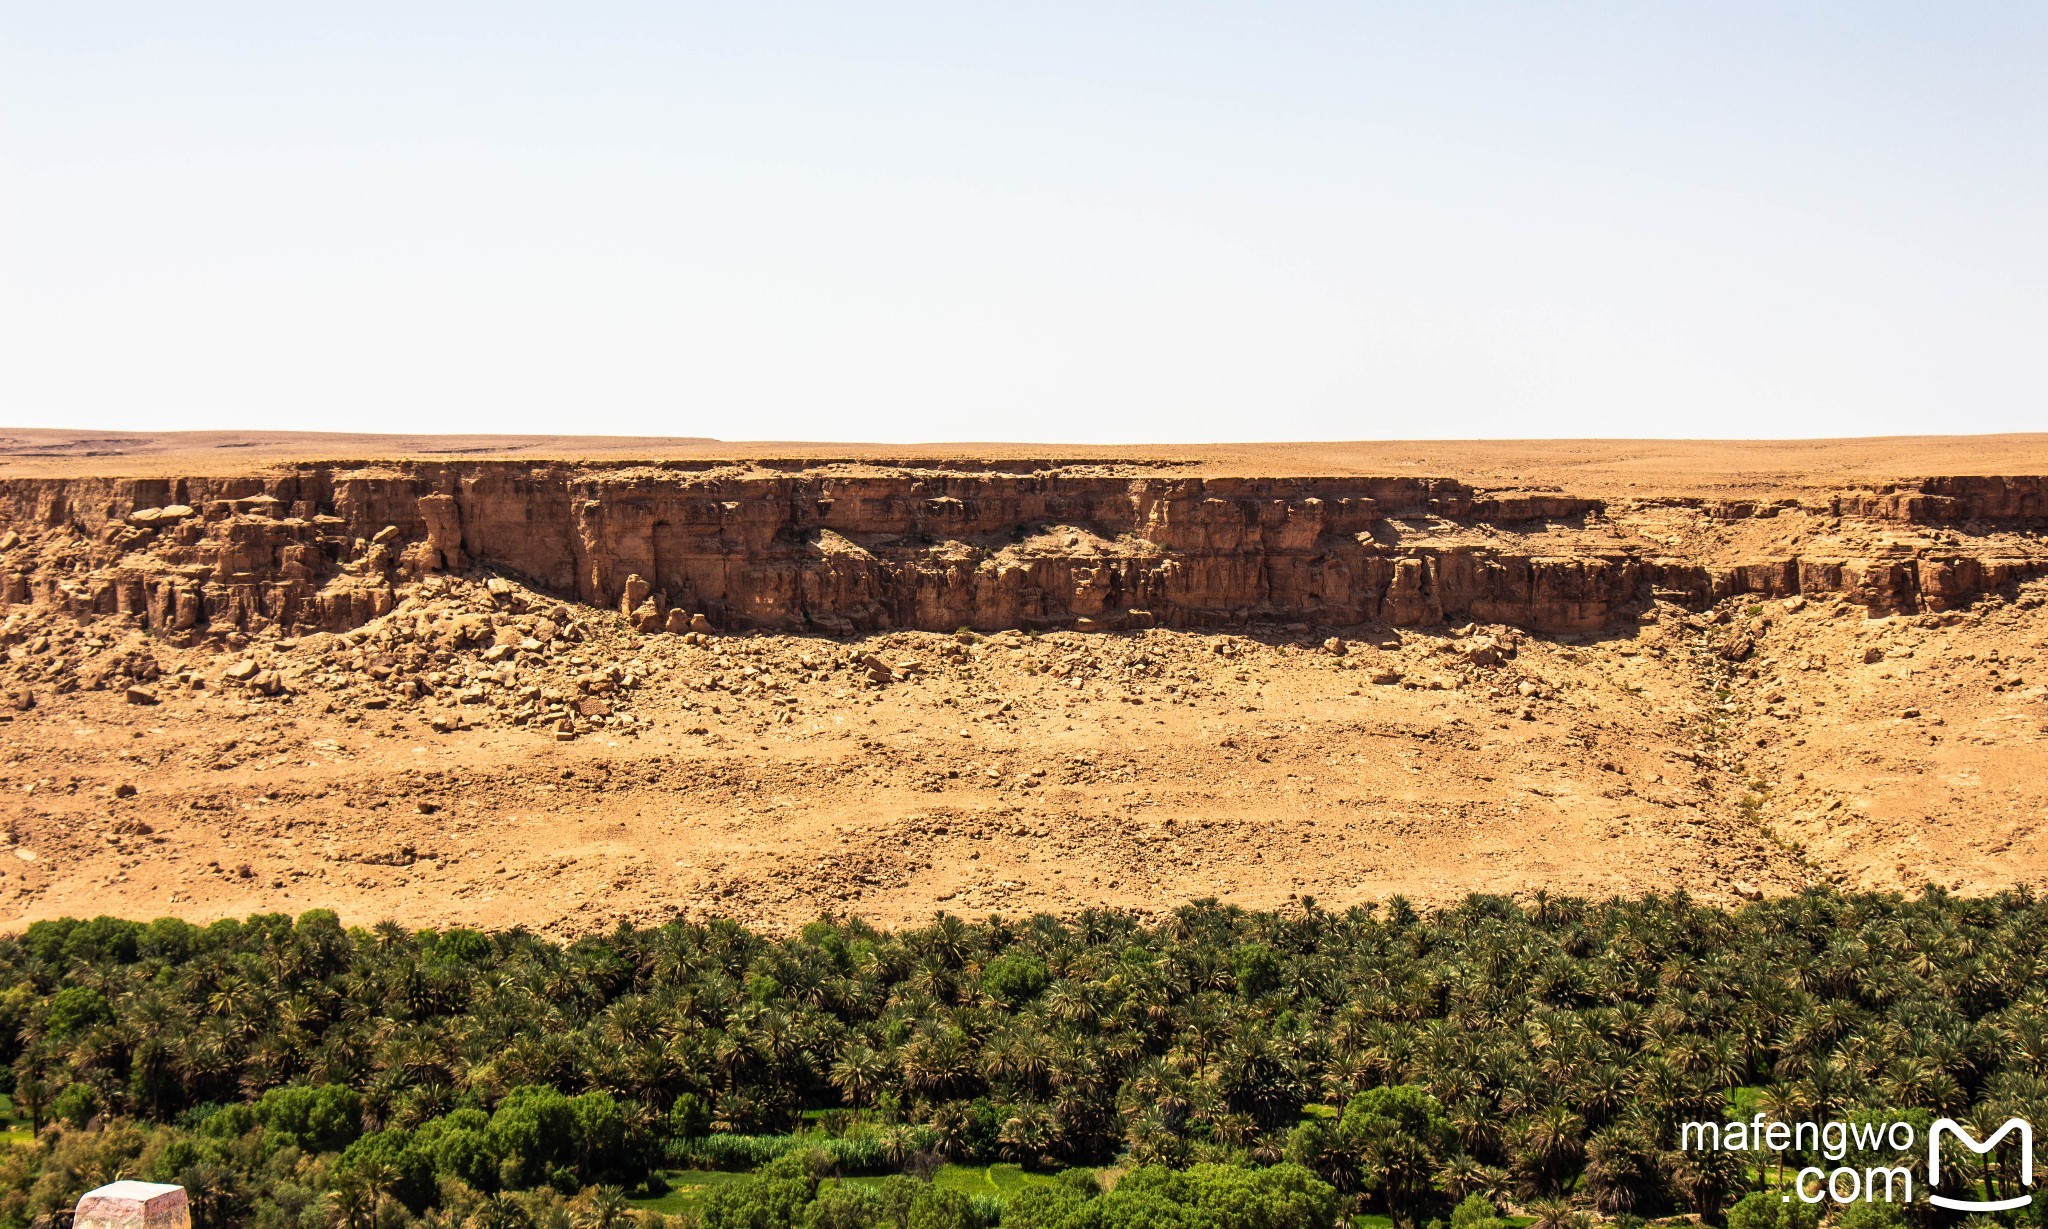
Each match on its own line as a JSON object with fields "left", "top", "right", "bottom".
{"left": 0, "top": 463, "right": 2048, "bottom": 635}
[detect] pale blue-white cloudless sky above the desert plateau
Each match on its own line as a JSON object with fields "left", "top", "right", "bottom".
{"left": 0, "top": 0, "right": 2048, "bottom": 442}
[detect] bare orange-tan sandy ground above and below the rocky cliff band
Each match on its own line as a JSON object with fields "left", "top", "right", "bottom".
{"left": 0, "top": 432, "right": 2048, "bottom": 934}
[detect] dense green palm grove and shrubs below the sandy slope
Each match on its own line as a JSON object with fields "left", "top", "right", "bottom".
{"left": 0, "top": 893, "right": 2048, "bottom": 1229}
